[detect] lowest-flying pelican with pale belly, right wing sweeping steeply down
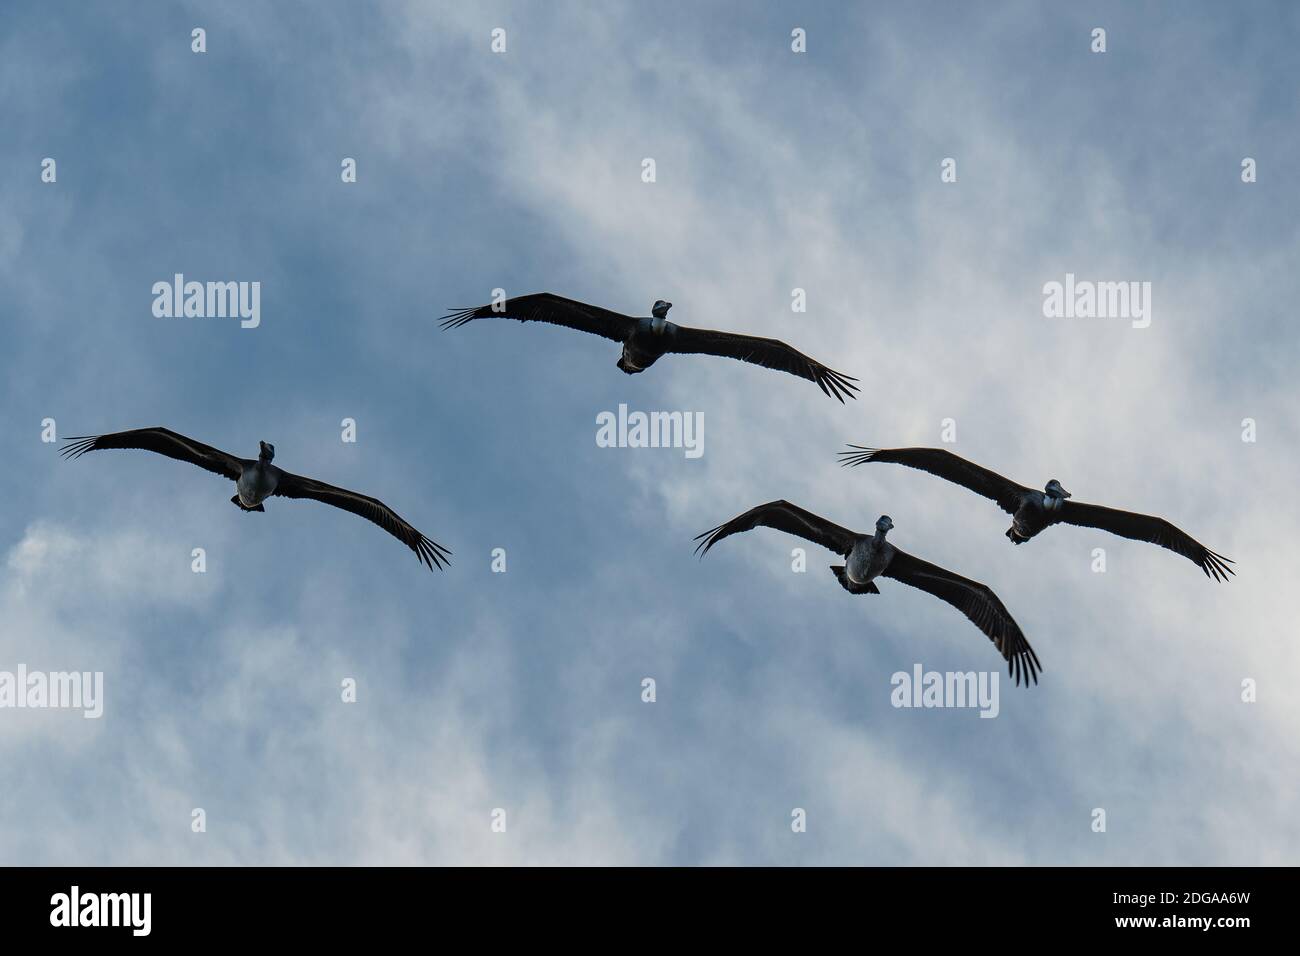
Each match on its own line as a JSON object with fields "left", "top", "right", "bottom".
{"left": 696, "top": 501, "right": 1043, "bottom": 687}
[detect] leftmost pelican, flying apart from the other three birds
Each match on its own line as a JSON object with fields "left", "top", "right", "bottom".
{"left": 61, "top": 428, "right": 451, "bottom": 571}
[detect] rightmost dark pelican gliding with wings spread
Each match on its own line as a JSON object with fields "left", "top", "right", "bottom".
{"left": 840, "top": 445, "right": 1235, "bottom": 581}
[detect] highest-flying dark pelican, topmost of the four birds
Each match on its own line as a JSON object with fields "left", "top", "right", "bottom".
{"left": 442, "top": 293, "right": 858, "bottom": 402}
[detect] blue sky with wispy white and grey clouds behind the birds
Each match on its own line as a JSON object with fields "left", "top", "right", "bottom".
{"left": 0, "top": 0, "right": 1300, "bottom": 865}
